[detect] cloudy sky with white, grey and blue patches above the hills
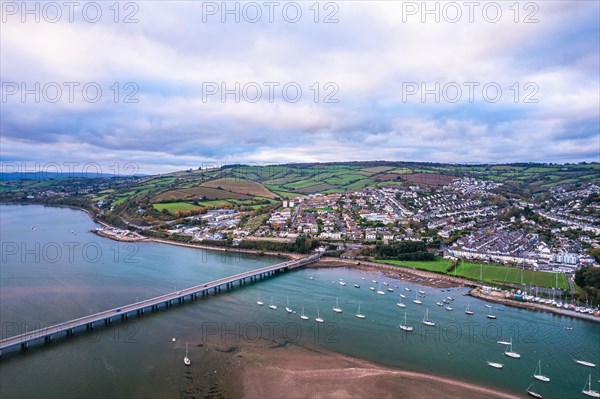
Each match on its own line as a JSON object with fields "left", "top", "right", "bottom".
{"left": 0, "top": 0, "right": 600, "bottom": 173}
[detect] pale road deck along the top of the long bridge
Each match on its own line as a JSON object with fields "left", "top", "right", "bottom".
{"left": 0, "top": 254, "right": 321, "bottom": 351}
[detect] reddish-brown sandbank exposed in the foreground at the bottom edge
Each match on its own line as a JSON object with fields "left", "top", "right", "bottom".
{"left": 196, "top": 340, "right": 519, "bottom": 399}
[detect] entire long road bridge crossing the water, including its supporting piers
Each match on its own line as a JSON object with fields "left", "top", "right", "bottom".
{"left": 0, "top": 253, "right": 322, "bottom": 354}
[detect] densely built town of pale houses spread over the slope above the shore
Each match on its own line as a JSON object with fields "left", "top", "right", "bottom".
{"left": 86, "top": 178, "right": 600, "bottom": 273}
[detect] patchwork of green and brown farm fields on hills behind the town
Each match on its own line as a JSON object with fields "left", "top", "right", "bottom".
{"left": 0, "top": 161, "right": 600, "bottom": 220}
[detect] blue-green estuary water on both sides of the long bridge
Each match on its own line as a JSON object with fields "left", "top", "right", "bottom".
{"left": 0, "top": 205, "right": 600, "bottom": 399}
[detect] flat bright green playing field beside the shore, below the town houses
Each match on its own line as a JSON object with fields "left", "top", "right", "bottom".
{"left": 377, "top": 259, "right": 569, "bottom": 289}
